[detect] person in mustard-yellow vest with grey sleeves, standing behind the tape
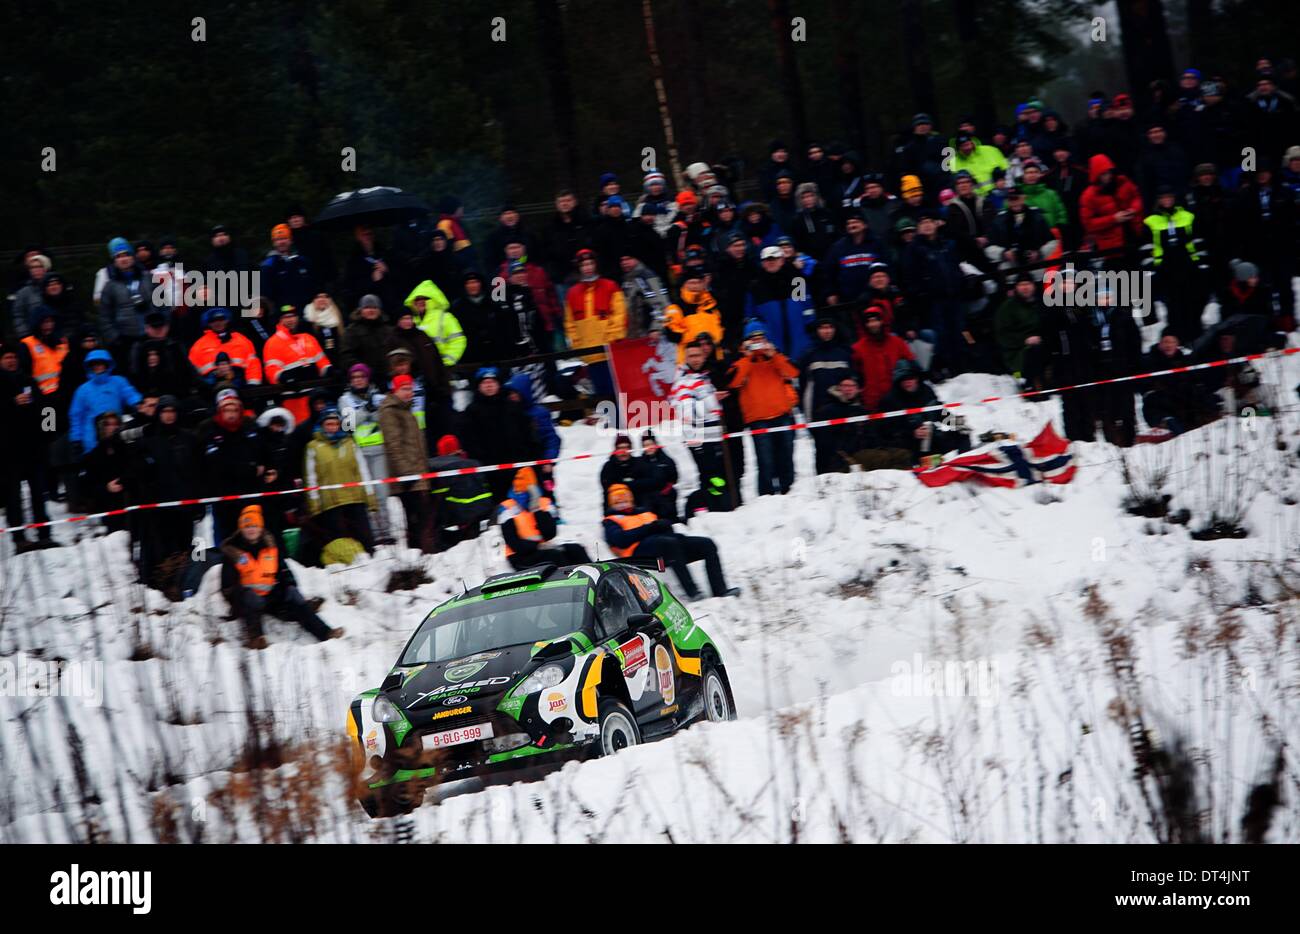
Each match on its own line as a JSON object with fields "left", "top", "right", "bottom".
{"left": 303, "top": 407, "right": 380, "bottom": 554}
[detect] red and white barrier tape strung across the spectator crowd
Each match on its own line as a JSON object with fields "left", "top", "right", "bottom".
{"left": 0, "top": 347, "right": 1300, "bottom": 535}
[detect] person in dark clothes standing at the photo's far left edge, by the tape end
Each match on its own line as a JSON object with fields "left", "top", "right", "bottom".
{"left": 0, "top": 338, "right": 52, "bottom": 554}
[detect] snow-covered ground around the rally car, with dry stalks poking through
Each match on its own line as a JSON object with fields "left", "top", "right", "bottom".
{"left": 0, "top": 343, "right": 1300, "bottom": 842}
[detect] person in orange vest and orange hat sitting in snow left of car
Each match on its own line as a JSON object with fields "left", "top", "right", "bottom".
{"left": 221, "top": 505, "right": 343, "bottom": 649}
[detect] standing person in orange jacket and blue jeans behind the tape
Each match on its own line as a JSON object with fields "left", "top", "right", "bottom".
{"left": 731, "top": 321, "right": 800, "bottom": 496}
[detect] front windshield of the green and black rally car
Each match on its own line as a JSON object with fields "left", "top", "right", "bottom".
{"left": 399, "top": 584, "right": 588, "bottom": 666}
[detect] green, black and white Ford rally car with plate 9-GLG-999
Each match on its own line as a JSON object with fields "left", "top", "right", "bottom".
{"left": 347, "top": 561, "right": 736, "bottom": 817}
